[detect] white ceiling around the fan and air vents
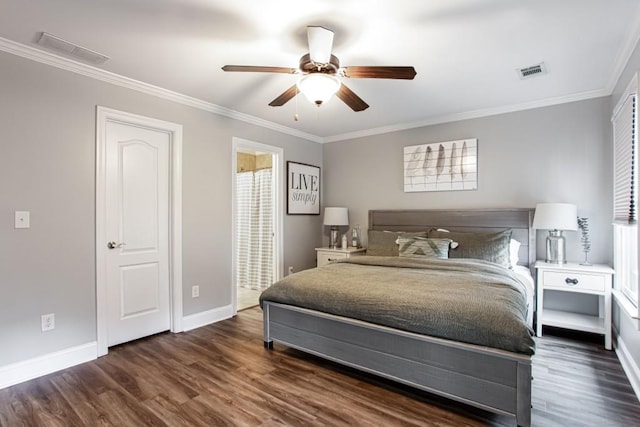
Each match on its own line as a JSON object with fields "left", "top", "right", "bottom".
{"left": 0, "top": 0, "right": 640, "bottom": 141}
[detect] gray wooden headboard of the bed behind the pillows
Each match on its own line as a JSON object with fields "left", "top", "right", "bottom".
{"left": 369, "top": 209, "right": 536, "bottom": 268}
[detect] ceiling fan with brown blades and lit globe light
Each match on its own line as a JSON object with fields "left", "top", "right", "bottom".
{"left": 222, "top": 26, "right": 416, "bottom": 111}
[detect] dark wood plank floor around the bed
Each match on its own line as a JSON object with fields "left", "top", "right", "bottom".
{"left": 0, "top": 308, "right": 640, "bottom": 427}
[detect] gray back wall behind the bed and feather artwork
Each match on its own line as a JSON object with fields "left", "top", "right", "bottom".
{"left": 324, "top": 98, "right": 612, "bottom": 263}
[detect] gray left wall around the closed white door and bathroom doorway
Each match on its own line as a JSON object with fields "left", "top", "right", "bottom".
{"left": 0, "top": 52, "right": 322, "bottom": 367}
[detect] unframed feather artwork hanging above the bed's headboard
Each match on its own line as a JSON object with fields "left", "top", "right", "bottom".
{"left": 404, "top": 138, "right": 478, "bottom": 193}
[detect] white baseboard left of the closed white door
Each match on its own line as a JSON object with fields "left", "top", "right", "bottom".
{"left": 0, "top": 342, "right": 98, "bottom": 389}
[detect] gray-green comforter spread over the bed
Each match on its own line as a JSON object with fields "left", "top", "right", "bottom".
{"left": 260, "top": 256, "right": 535, "bottom": 355}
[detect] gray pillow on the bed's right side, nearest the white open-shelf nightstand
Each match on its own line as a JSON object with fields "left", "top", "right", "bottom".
{"left": 429, "top": 229, "right": 511, "bottom": 268}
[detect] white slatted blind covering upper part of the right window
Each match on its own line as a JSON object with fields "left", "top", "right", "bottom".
{"left": 613, "top": 93, "right": 638, "bottom": 224}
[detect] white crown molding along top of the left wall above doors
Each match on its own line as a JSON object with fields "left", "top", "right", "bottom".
{"left": 0, "top": 37, "right": 323, "bottom": 142}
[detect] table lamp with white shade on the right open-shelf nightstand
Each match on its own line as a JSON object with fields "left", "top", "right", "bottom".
{"left": 533, "top": 203, "right": 578, "bottom": 264}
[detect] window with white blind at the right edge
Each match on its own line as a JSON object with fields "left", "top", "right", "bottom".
{"left": 611, "top": 75, "right": 640, "bottom": 317}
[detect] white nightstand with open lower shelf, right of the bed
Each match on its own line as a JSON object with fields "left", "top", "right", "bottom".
{"left": 535, "top": 261, "right": 614, "bottom": 350}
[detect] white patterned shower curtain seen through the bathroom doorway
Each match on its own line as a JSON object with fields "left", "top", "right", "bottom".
{"left": 236, "top": 169, "right": 273, "bottom": 289}
